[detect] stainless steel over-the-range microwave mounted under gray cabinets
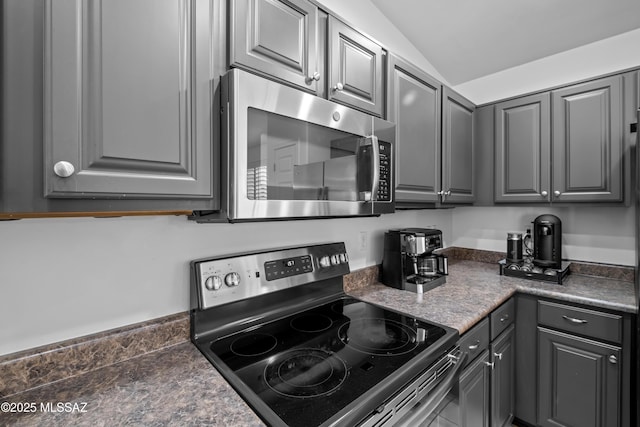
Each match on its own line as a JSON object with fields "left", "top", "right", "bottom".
{"left": 205, "top": 69, "right": 395, "bottom": 222}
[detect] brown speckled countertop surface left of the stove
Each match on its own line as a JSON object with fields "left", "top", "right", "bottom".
{"left": 0, "top": 342, "right": 264, "bottom": 427}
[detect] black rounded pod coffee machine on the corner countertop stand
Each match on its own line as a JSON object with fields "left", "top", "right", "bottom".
{"left": 533, "top": 214, "right": 562, "bottom": 268}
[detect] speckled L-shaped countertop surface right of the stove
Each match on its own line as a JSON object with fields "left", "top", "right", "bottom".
{"left": 348, "top": 261, "right": 638, "bottom": 335}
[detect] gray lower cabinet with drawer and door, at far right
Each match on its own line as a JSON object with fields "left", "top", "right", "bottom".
{"left": 515, "top": 295, "right": 634, "bottom": 427}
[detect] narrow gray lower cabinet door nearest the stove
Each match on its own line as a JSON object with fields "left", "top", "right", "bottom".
{"left": 458, "top": 351, "right": 490, "bottom": 427}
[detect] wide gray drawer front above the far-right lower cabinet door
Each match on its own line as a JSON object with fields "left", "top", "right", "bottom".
{"left": 538, "top": 301, "right": 622, "bottom": 343}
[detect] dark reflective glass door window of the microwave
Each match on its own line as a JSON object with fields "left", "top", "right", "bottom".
{"left": 246, "top": 108, "right": 373, "bottom": 201}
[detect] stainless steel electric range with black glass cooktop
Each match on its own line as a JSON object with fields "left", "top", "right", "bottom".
{"left": 190, "top": 243, "right": 462, "bottom": 427}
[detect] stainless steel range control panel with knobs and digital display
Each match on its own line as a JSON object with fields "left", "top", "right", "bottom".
{"left": 191, "top": 243, "right": 350, "bottom": 309}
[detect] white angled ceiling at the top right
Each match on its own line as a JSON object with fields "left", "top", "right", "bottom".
{"left": 371, "top": 0, "right": 640, "bottom": 85}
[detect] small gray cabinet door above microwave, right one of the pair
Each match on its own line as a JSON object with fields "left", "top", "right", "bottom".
{"left": 328, "top": 16, "right": 384, "bottom": 117}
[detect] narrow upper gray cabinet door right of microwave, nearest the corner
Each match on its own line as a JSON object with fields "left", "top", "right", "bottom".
{"left": 442, "top": 86, "right": 475, "bottom": 203}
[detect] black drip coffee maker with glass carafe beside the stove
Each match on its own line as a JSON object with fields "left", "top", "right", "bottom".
{"left": 382, "top": 228, "right": 448, "bottom": 293}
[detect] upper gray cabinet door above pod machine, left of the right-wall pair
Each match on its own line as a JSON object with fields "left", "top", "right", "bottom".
{"left": 494, "top": 93, "right": 551, "bottom": 202}
